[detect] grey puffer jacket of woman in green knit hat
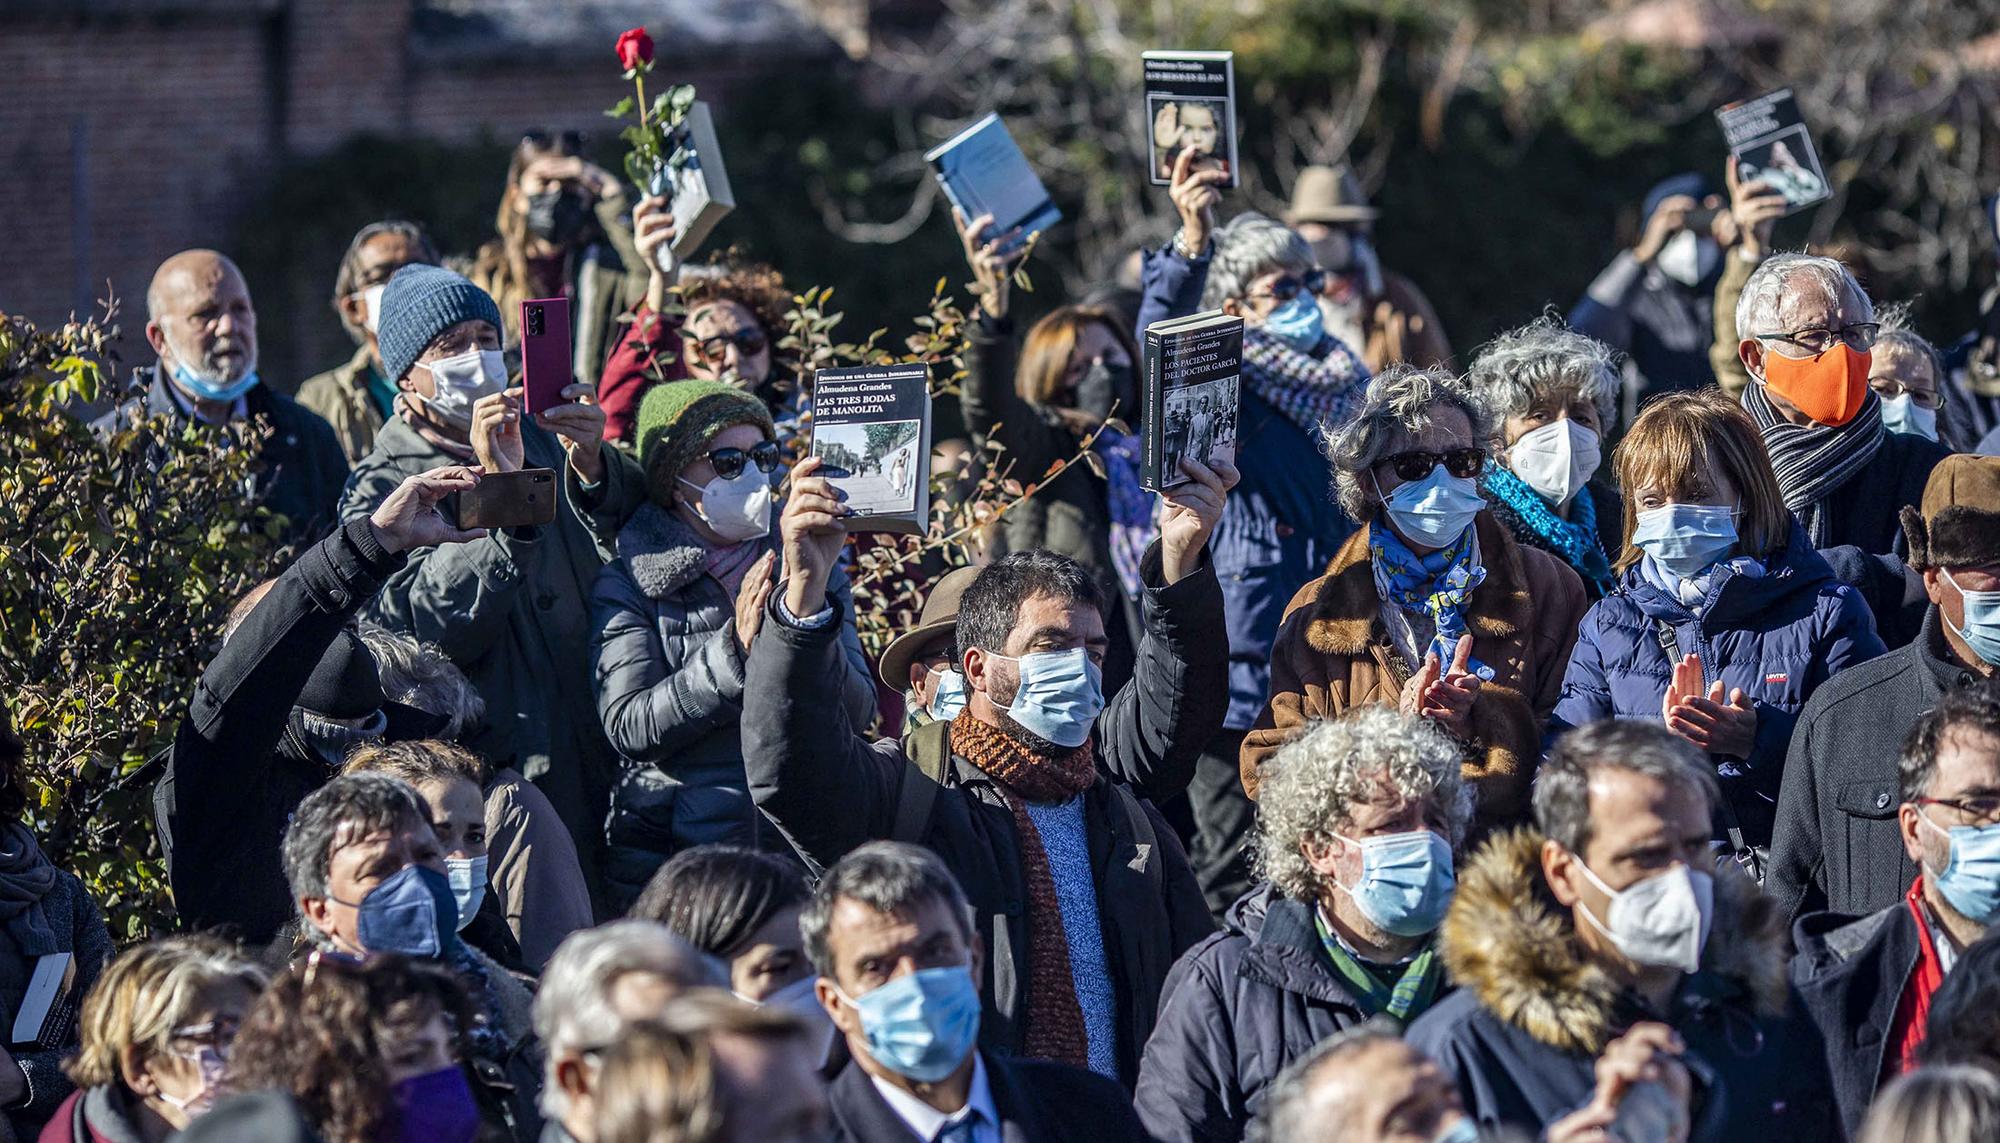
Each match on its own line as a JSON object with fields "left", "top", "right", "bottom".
{"left": 590, "top": 502, "right": 876, "bottom": 911}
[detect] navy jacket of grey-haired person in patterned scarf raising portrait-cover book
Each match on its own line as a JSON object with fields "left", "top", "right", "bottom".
{"left": 1138, "top": 244, "right": 1368, "bottom": 729}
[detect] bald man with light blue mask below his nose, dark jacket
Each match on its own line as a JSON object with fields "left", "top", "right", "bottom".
{"left": 92, "top": 250, "right": 348, "bottom": 544}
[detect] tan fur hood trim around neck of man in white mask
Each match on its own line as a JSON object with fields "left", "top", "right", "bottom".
{"left": 1438, "top": 829, "right": 1786, "bottom": 1055}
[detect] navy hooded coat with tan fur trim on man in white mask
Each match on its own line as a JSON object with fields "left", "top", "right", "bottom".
{"left": 1408, "top": 829, "right": 1824, "bottom": 1143}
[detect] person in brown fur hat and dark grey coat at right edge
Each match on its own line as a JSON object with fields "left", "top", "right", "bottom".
{"left": 1764, "top": 456, "right": 2000, "bottom": 919}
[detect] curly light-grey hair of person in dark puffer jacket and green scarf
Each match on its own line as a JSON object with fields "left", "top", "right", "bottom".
{"left": 1256, "top": 705, "right": 1472, "bottom": 901}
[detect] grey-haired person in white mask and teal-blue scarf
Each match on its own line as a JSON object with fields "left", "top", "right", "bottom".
{"left": 1466, "top": 318, "right": 1624, "bottom": 599}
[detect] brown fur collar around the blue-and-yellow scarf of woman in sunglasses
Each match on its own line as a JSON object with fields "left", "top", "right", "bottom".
{"left": 1306, "top": 512, "right": 1532, "bottom": 655}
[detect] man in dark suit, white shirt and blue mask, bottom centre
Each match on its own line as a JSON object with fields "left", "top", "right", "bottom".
{"left": 798, "top": 841, "right": 1146, "bottom": 1143}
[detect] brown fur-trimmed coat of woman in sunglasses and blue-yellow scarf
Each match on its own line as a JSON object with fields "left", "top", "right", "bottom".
{"left": 1242, "top": 512, "right": 1590, "bottom": 833}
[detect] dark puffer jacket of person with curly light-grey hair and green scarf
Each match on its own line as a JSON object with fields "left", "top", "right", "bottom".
{"left": 1134, "top": 885, "right": 1416, "bottom": 1143}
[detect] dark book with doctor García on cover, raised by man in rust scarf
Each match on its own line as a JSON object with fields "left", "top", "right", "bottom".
{"left": 1140, "top": 310, "right": 1244, "bottom": 492}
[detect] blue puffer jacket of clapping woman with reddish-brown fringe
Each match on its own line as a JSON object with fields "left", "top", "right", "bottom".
{"left": 1550, "top": 522, "right": 1882, "bottom": 845}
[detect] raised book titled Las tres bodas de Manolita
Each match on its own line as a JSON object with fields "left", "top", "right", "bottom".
{"left": 812, "top": 362, "right": 930, "bottom": 534}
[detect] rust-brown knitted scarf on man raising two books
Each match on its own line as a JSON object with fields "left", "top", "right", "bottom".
{"left": 952, "top": 709, "right": 1098, "bottom": 1067}
